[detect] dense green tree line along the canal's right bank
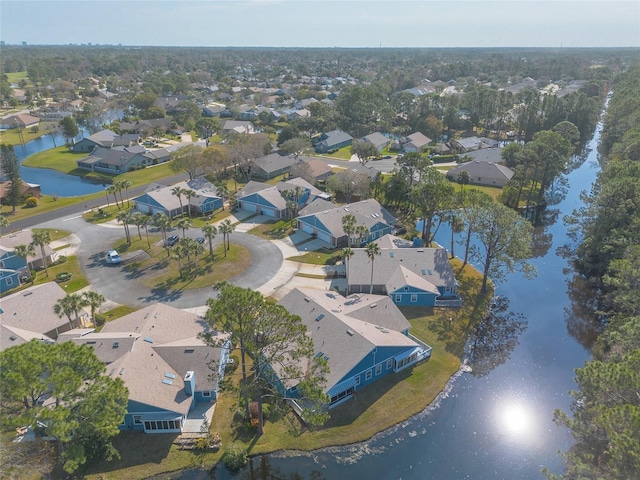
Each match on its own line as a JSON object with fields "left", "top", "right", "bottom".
{"left": 549, "top": 68, "right": 640, "bottom": 479}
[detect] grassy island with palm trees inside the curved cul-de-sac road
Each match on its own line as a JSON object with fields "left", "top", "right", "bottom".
{"left": 136, "top": 244, "right": 251, "bottom": 290}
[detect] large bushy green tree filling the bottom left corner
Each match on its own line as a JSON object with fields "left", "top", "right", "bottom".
{"left": 0, "top": 340, "right": 128, "bottom": 473}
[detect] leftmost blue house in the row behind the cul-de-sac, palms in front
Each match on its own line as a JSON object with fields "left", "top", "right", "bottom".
{"left": 132, "top": 177, "right": 223, "bottom": 218}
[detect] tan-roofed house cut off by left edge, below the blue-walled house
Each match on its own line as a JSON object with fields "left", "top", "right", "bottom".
{"left": 0, "top": 282, "right": 79, "bottom": 348}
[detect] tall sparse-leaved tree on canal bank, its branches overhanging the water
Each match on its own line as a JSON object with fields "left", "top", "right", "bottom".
{"left": 471, "top": 203, "right": 536, "bottom": 293}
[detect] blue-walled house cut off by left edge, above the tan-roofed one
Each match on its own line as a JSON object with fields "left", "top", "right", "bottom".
{"left": 0, "top": 230, "right": 57, "bottom": 292}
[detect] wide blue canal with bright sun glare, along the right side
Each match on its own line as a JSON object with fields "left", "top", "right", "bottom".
{"left": 186, "top": 109, "right": 601, "bottom": 480}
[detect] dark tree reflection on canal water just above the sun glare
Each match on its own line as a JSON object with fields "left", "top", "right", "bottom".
{"left": 468, "top": 297, "right": 527, "bottom": 377}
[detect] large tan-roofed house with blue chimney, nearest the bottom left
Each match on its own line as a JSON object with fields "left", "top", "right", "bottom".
{"left": 64, "top": 303, "right": 230, "bottom": 433}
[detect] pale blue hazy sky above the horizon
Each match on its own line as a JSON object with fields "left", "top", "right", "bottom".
{"left": 0, "top": 0, "right": 640, "bottom": 48}
